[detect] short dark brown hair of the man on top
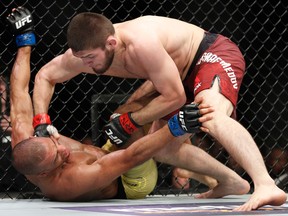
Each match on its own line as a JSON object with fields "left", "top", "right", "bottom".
{"left": 67, "top": 12, "right": 115, "bottom": 52}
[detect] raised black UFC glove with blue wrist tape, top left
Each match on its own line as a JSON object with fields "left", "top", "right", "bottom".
{"left": 7, "top": 7, "right": 36, "bottom": 47}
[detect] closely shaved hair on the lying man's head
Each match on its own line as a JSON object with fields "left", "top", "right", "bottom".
{"left": 12, "top": 138, "right": 47, "bottom": 175}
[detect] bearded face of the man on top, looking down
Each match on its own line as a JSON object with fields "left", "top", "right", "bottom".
{"left": 73, "top": 47, "right": 114, "bottom": 75}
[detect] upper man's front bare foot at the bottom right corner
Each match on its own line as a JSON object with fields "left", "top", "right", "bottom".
{"left": 234, "top": 184, "right": 287, "bottom": 211}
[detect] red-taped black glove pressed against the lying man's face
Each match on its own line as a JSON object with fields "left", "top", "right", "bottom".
{"left": 33, "top": 113, "right": 52, "bottom": 137}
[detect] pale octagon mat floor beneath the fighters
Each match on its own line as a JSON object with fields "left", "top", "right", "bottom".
{"left": 0, "top": 194, "right": 288, "bottom": 216}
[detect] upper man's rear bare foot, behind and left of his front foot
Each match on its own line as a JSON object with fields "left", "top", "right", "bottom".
{"left": 194, "top": 178, "right": 250, "bottom": 199}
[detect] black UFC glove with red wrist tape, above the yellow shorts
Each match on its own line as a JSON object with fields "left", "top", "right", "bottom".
{"left": 103, "top": 112, "right": 140, "bottom": 147}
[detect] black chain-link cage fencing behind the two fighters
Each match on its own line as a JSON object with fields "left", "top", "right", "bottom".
{"left": 0, "top": 0, "right": 288, "bottom": 198}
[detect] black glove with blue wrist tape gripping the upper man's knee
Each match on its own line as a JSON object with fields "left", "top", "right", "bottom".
{"left": 168, "top": 103, "right": 201, "bottom": 137}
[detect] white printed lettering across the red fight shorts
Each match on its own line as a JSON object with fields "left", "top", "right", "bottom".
{"left": 196, "top": 52, "right": 238, "bottom": 89}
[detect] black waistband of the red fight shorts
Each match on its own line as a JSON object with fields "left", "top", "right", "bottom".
{"left": 183, "top": 32, "right": 219, "bottom": 82}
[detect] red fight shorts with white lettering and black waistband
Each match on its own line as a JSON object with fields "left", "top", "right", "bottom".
{"left": 163, "top": 32, "right": 245, "bottom": 120}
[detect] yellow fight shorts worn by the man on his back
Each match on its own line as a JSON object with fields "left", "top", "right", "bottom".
{"left": 102, "top": 140, "right": 158, "bottom": 199}
